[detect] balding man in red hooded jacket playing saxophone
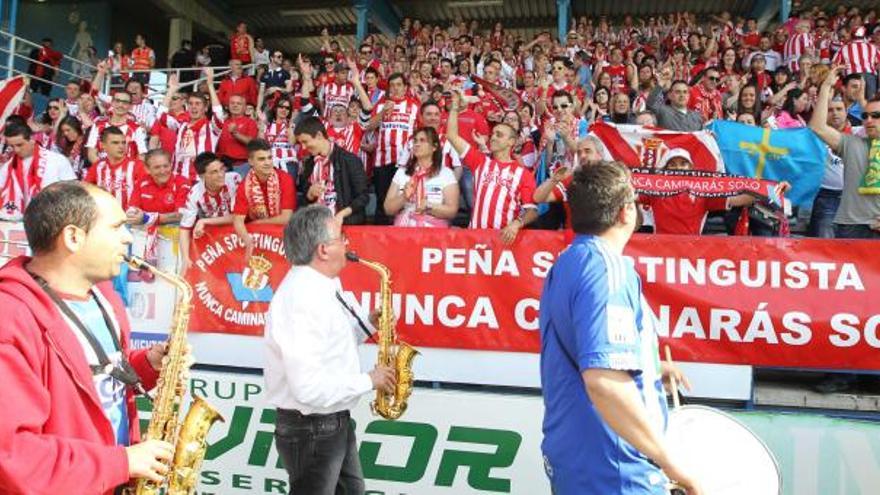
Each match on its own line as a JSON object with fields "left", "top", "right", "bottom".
{"left": 0, "top": 181, "right": 173, "bottom": 495}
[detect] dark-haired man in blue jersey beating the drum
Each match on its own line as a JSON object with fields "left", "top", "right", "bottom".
{"left": 540, "top": 162, "right": 701, "bottom": 495}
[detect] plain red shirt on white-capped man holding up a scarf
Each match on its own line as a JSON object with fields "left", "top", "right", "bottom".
{"left": 639, "top": 193, "right": 727, "bottom": 235}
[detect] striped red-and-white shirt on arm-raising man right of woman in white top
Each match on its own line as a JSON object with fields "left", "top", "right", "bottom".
{"left": 462, "top": 146, "right": 536, "bottom": 229}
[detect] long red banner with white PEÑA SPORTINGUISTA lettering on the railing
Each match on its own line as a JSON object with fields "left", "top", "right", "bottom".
{"left": 188, "top": 227, "right": 880, "bottom": 369}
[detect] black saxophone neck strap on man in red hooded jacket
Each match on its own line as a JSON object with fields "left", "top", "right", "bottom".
{"left": 28, "top": 271, "right": 145, "bottom": 394}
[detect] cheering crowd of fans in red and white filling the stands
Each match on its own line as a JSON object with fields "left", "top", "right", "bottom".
{"left": 0, "top": 3, "right": 880, "bottom": 268}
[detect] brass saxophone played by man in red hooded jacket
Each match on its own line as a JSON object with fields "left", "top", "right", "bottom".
{"left": 126, "top": 256, "right": 223, "bottom": 495}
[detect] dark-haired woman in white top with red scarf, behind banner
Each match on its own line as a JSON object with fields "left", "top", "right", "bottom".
{"left": 385, "top": 127, "right": 459, "bottom": 227}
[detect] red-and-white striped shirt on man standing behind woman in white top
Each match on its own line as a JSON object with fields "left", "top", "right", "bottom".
{"left": 373, "top": 96, "right": 421, "bottom": 167}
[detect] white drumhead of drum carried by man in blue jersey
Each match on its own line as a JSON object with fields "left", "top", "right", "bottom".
{"left": 666, "top": 406, "right": 782, "bottom": 495}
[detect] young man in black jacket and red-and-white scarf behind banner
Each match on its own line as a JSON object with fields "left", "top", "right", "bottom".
{"left": 293, "top": 117, "right": 369, "bottom": 225}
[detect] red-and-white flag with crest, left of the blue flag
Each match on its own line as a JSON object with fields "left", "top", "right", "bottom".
{"left": 590, "top": 122, "right": 724, "bottom": 172}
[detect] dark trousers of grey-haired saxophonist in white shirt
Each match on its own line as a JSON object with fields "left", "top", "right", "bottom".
{"left": 275, "top": 409, "right": 365, "bottom": 495}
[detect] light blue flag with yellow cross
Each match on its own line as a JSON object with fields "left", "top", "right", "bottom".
{"left": 709, "top": 120, "right": 828, "bottom": 206}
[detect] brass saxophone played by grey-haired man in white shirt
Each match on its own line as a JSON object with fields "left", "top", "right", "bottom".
{"left": 345, "top": 252, "right": 419, "bottom": 419}
